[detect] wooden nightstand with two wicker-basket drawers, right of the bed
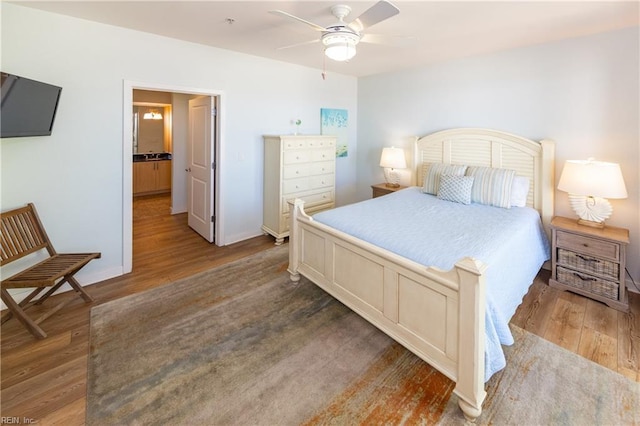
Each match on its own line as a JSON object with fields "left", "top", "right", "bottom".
{"left": 549, "top": 216, "right": 629, "bottom": 312}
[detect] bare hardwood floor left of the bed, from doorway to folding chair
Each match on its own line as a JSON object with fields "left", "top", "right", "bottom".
{"left": 0, "top": 197, "right": 273, "bottom": 426}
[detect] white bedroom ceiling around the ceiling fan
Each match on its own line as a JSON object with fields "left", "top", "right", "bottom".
{"left": 12, "top": 0, "right": 640, "bottom": 76}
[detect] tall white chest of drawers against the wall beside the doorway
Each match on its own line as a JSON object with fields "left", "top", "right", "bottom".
{"left": 262, "top": 135, "right": 336, "bottom": 244}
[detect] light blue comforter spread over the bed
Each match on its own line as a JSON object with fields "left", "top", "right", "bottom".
{"left": 313, "top": 187, "right": 550, "bottom": 380}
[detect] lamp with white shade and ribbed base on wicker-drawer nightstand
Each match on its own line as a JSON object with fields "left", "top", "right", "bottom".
{"left": 558, "top": 158, "right": 627, "bottom": 228}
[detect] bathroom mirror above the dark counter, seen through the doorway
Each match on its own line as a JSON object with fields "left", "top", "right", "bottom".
{"left": 133, "top": 103, "right": 171, "bottom": 154}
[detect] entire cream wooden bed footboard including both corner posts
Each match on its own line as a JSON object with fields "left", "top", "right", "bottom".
{"left": 289, "top": 204, "right": 485, "bottom": 418}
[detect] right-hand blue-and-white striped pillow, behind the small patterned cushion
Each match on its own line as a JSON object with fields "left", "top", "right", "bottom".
{"left": 466, "top": 166, "right": 516, "bottom": 209}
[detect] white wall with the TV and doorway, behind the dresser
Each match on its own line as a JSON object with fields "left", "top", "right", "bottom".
{"left": 0, "top": 2, "right": 357, "bottom": 292}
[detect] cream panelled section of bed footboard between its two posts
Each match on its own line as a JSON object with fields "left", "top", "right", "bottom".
{"left": 298, "top": 225, "right": 458, "bottom": 380}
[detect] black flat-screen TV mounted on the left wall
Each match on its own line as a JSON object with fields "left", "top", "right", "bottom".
{"left": 0, "top": 72, "right": 62, "bottom": 138}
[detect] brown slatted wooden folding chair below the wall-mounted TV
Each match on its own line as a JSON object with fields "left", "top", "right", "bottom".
{"left": 0, "top": 203, "right": 100, "bottom": 339}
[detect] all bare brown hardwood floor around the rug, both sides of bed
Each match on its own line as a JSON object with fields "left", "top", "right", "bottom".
{"left": 0, "top": 197, "right": 640, "bottom": 426}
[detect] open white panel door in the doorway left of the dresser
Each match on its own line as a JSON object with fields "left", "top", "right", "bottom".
{"left": 187, "top": 96, "right": 215, "bottom": 243}
